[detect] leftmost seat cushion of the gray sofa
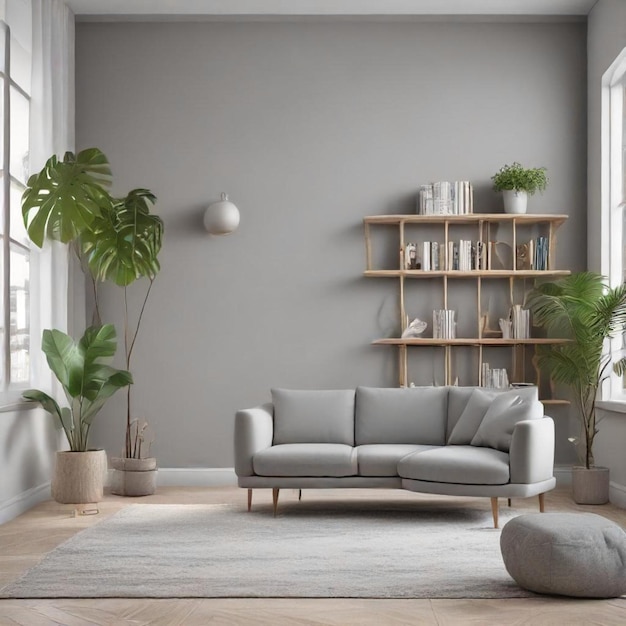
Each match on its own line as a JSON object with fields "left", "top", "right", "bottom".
{"left": 252, "top": 443, "right": 358, "bottom": 476}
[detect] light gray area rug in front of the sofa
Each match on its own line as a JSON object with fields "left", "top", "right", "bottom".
{"left": 0, "top": 492, "right": 532, "bottom": 598}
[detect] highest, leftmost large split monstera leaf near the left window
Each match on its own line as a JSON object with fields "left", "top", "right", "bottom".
{"left": 22, "top": 148, "right": 112, "bottom": 248}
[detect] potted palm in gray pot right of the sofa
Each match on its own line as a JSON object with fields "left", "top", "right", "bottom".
{"left": 528, "top": 272, "right": 626, "bottom": 504}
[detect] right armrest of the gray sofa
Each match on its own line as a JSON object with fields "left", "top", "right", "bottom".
{"left": 509, "top": 417, "right": 554, "bottom": 484}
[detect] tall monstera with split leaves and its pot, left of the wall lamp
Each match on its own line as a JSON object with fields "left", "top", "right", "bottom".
{"left": 22, "top": 148, "right": 163, "bottom": 495}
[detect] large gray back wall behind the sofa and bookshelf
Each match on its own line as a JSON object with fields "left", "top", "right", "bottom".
{"left": 76, "top": 21, "right": 586, "bottom": 467}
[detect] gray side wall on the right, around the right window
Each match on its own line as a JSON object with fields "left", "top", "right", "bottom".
{"left": 587, "top": 0, "right": 626, "bottom": 498}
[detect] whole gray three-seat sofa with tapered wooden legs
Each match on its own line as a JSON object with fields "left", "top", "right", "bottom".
{"left": 234, "top": 387, "right": 556, "bottom": 528}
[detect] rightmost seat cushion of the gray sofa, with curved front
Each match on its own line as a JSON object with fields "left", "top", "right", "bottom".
{"left": 398, "top": 446, "right": 509, "bottom": 485}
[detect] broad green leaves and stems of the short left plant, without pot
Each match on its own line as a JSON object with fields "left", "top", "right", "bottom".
{"left": 22, "top": 324, "right": 133, "bottom": 452}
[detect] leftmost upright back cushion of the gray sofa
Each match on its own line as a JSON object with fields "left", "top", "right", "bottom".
{"left": 272, "top": 389, "right": 354, "bottom": 446}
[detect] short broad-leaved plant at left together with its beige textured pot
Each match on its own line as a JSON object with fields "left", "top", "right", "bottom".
{"left": 22, "top": 324, "right": 133, "bottom": 504}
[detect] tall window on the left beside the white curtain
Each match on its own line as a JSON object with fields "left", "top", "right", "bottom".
{"left": 0, "top": 21, "right": 31, "bottom": 392}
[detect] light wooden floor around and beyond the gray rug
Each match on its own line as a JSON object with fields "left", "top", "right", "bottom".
{"left": 0, "top": 487, "right": 626, "bottom": 626}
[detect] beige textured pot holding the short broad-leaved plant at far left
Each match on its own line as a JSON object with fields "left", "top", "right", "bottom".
{"left": 51, "top": 450, "right": 107, "bottom": 504}
